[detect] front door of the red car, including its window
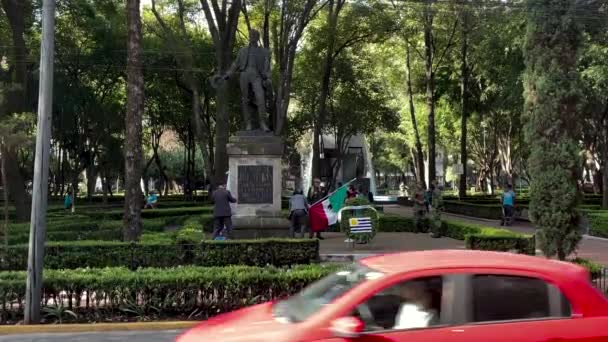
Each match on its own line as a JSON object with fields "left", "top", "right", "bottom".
{"left": 325, "top": 275, "right": 464, "bottom": 342}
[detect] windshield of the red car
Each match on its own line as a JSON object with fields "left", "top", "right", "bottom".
{"left": 274, "top": 264, "right": 382, "bottom": 322}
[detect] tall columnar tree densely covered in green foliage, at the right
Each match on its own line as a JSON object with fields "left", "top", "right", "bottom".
{"left": 524, "top": 0, "right": 582, "bottom": 260}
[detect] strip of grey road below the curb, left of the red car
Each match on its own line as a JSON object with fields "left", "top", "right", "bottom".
{"left": 0, "top": 330, "right": 180, "bottom": 342}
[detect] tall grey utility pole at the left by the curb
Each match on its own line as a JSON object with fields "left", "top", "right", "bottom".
{"left": 25, "top": 0, "right": 55, "bottom": 324}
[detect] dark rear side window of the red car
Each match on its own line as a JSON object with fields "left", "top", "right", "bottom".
{"left": 472, "top": 275, "right": 571, "bottom": 322}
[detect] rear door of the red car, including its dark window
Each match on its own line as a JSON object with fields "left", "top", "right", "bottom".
{"left": 455, "top": 274, "right": 608, "bottom": 342}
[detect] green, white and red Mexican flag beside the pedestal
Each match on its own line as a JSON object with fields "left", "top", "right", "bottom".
{"left": 308, "top": 182, "right": 351, "bottom": 232}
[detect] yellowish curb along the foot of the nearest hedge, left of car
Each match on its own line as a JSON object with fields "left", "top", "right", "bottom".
{"left": 0, "top": 321, "right": 199, "bottom": 336}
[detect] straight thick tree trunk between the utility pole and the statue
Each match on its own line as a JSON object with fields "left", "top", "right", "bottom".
{"left": 123, "top": 0, "right": 144, "bottom": 241}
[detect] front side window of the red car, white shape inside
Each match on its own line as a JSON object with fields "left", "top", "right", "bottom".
{"left": 353, "top": 277, "right": 443, "bottom": 332}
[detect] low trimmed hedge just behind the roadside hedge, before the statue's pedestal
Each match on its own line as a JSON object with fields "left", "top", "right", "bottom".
{"left": 0, "top": 239, "right": 319, "bottom": 270}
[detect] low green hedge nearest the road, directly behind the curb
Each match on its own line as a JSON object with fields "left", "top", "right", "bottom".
{"left": 0, "top": 265, "right": 337, "bottom": 320}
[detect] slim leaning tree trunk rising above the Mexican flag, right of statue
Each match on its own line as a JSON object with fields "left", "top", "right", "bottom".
{"left": 312, "top": 0, "right": 345, "bottom": 177}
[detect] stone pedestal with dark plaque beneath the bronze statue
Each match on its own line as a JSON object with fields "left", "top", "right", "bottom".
{"left": 227, "top": 132, "right": 290, "bottom": 238}
